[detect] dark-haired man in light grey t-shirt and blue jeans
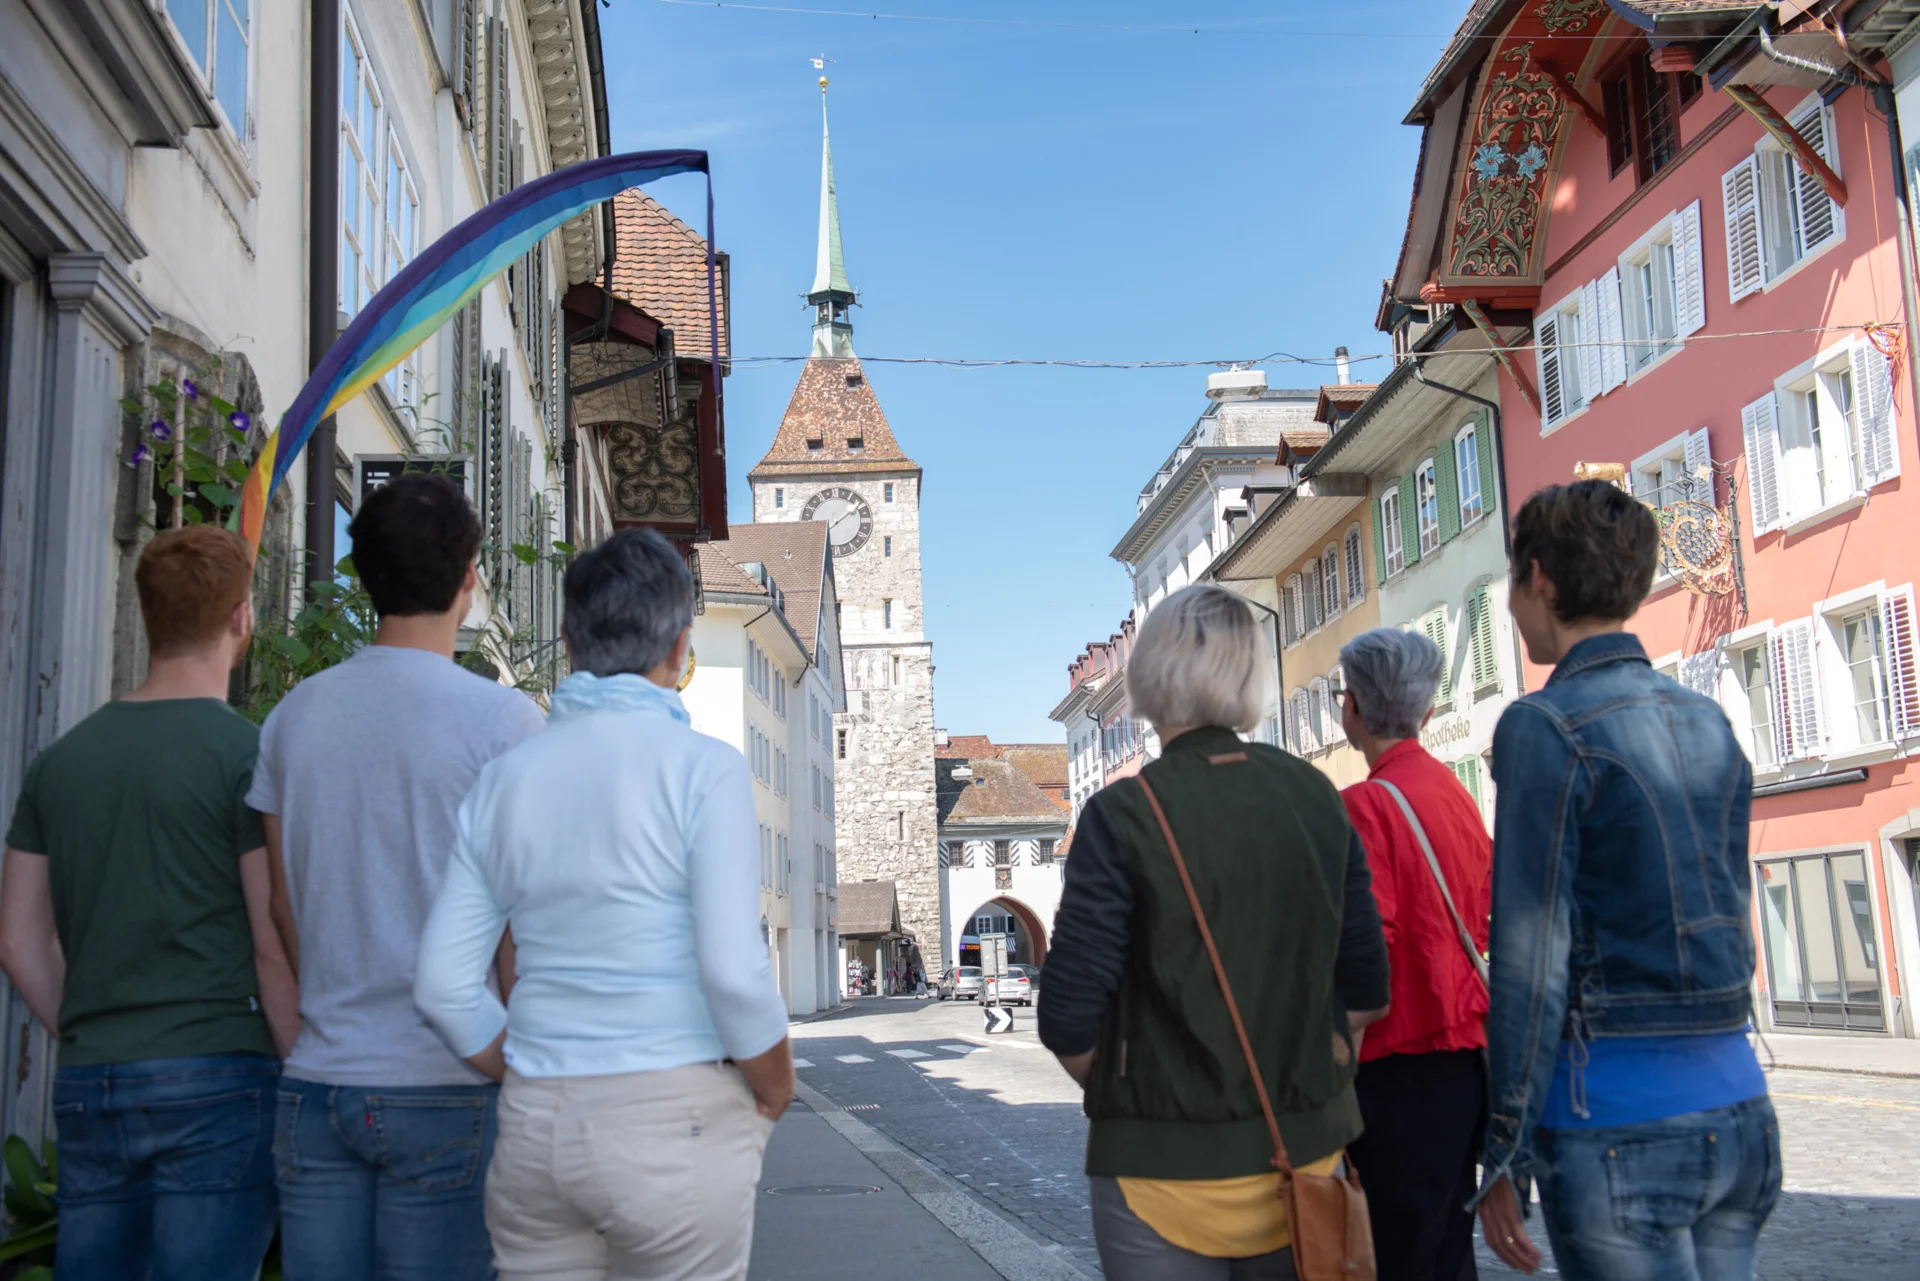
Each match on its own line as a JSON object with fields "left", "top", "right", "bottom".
{"left": 248, "top": 476, "right": 541, "bottom": 1281}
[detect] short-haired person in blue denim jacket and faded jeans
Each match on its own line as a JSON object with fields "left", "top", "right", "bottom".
{"left": 1480, "top": 480, "right": 1780, "bottom": 1281}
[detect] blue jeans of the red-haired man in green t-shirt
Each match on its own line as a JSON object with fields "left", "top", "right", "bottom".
{"left": 54, "top": 1054, "right": 280, "bottom": 1281}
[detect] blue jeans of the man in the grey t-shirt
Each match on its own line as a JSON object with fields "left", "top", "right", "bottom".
{"left": 273, "top": 1077, "right": 499, "bottom": 1281}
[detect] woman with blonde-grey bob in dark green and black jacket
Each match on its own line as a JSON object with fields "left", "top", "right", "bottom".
{"left": 1039, "top": 586, "right": 1388, "bottom": 1281}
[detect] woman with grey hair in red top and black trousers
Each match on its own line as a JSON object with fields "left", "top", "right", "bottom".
{"left": 1340, "top": 628, "right": 1494, "bottom": 1281}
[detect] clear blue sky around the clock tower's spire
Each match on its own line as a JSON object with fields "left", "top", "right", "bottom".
{"left": 601, "top": 0, "right": 1467, "bottom": 741}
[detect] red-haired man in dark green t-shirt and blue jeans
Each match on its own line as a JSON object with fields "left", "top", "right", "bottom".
{"left": 0, "top": 526, "right": 300, "bottom": 1281}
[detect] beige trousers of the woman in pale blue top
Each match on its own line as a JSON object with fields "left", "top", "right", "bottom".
{"left": 486, "top": 1064, "right": 774, "bottom": 1281}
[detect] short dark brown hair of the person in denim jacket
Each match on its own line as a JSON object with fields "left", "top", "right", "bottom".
{"left": 1513, "top": 480, "right": 1661, "bottom": 622}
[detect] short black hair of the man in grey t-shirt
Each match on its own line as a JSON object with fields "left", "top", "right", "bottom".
{"left": 348, "top": 472, "right": 480, "bottom": 618}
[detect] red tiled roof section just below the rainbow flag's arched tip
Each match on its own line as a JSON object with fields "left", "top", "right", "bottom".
{"left": 612, "top": 190, "right": 730, "bottom": 359}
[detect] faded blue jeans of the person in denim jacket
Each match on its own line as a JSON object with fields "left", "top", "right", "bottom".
{"left": 1534, "top": 1095, "right": 1780, "bottom": 1281}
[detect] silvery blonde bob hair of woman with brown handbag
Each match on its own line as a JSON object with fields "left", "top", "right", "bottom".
{"left": 1127, "top": 584, "right": 1273, "bottom": 730}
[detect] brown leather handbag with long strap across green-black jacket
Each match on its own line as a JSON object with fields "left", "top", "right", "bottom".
{"left": 1135, "top": 776, "right": 1375, "bottom": 1281}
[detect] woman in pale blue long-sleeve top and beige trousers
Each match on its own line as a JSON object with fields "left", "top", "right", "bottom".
{"left": 413, "top": 530, "right": 793, "bottom": 1281}
